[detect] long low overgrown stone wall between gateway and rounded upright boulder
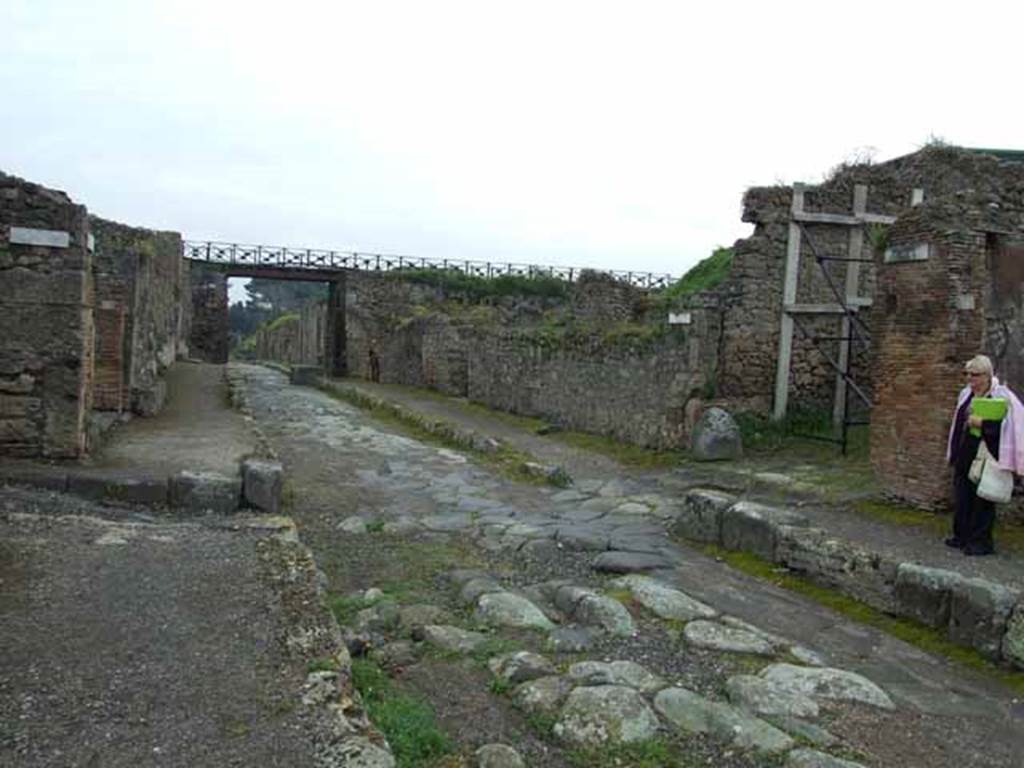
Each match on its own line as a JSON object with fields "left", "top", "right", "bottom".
{"left": 257, "top": 273, "right": 720, "bottom": 447}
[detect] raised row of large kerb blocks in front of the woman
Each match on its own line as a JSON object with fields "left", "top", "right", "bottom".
{"left": 672, "top": 488, "right": 1024, "bottom": 670}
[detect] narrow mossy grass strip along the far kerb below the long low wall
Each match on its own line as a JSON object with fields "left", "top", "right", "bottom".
{"left": 324, "top": 385, "right": 569, "bottom": 487}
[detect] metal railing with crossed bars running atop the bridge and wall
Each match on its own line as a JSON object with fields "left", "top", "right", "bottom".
{"left": 183, "top": 241, "right": 675, "bottom": 290}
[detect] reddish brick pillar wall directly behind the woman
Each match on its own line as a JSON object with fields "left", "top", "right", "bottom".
{"left": 870, "top": 184, "right": 1024, "bottom": 508}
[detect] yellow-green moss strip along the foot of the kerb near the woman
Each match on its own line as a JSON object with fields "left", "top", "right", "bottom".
{"left": 703, "top": 546, "right": 1024, "bottom": 694}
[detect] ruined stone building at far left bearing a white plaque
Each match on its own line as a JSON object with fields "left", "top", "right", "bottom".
{"left": 0, "top": 174, "right": 190, "bottom": 458}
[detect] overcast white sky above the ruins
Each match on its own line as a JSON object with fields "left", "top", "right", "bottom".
{"left": 0, "top": 0, "right": 1024, "bottom": 301}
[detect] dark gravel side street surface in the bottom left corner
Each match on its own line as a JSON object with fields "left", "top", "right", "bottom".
{"left": 0, "top": 488, "right": 337, "bottom": 768}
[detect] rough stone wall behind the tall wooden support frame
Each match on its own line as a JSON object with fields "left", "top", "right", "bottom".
{"left": 719, "top": 146, "right": 1016, "bottom": 411}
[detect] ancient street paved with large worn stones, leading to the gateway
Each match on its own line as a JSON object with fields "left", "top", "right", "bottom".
{"left": 233, "top": 366, "right": 1022, "bottom": 768}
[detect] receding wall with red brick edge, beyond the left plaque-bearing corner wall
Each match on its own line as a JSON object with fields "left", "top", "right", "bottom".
{"left": 90, "top": 216, "right": 189, "bottom": 415}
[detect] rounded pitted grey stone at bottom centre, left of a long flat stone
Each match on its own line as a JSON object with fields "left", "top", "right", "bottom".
{"left": 554, "top": 685, "right": 658, "bottom": 746}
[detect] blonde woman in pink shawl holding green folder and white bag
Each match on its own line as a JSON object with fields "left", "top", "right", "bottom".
{"left": 946, "top": 354, "right": 1024, "bottom": 555}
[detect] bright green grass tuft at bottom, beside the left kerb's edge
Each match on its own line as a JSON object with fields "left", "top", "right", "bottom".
{"left": 352, "top": 658, "right": 455, "bottom": 768}
